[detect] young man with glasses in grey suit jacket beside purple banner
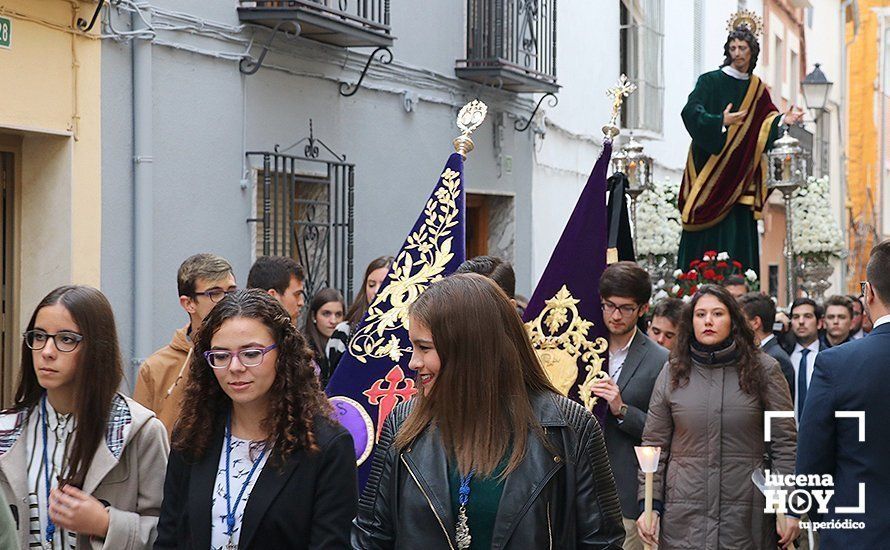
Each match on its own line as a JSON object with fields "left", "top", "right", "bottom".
{"left": 593, "top": 262, "right": 668, "bottom": 550}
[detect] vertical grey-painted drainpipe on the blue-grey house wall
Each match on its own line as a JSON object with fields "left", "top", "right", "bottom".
{"left": 131, "top": 3, "right": 154, "bottom": 383}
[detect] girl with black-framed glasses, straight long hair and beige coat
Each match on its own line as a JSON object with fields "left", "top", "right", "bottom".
{"left": 0, "top": 286, "right": 169, "bottom": 550}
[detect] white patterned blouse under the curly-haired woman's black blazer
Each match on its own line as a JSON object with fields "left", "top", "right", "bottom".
{"left": 210, "top": 436, "right": 269, "bottom": 550}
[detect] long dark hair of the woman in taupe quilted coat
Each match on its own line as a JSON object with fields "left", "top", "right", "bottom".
{"left": 670, "top": 285, "right": 766, "bottom": 397}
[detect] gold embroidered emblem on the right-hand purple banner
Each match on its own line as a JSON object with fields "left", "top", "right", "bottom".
{"left": 525, "top": 285, "right": 609, "bottom": 411}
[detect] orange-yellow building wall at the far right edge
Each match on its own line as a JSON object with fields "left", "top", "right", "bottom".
{"left": 847, "top": 0, "right": 890, "bottom": 292}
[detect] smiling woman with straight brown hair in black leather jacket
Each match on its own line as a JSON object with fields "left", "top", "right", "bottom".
{"left": 352, "top": 274, "right": 624, "bottom": 550}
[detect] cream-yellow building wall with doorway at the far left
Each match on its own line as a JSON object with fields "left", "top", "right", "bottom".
{"left": 0, "top": 0, "right": 102, "bottom": 406}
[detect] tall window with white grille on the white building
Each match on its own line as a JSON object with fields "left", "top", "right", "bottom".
{"left": 619, "top": 0, "right": 664, "bottom": 134}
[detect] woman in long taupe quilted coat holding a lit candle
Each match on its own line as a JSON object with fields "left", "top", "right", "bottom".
{"left": 637, "top": 285, "right": 800, "bottom": 550}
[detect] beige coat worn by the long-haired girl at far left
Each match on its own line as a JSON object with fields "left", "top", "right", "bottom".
{"left": 0, "top": 395, "right": 170, "bottom": 550}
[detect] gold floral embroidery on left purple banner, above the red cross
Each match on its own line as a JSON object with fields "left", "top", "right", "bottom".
{"left": 349, "top": 168, "right": 461, "bottom": 363}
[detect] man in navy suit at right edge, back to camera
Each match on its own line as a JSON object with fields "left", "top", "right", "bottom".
{"left": 797, "top": 241, "right": 890, "bottom": 549}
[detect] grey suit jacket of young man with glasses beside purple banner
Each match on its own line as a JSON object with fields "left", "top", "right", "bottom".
{"left": 603, "top": 330, "right": 668, "bottom": 519}
